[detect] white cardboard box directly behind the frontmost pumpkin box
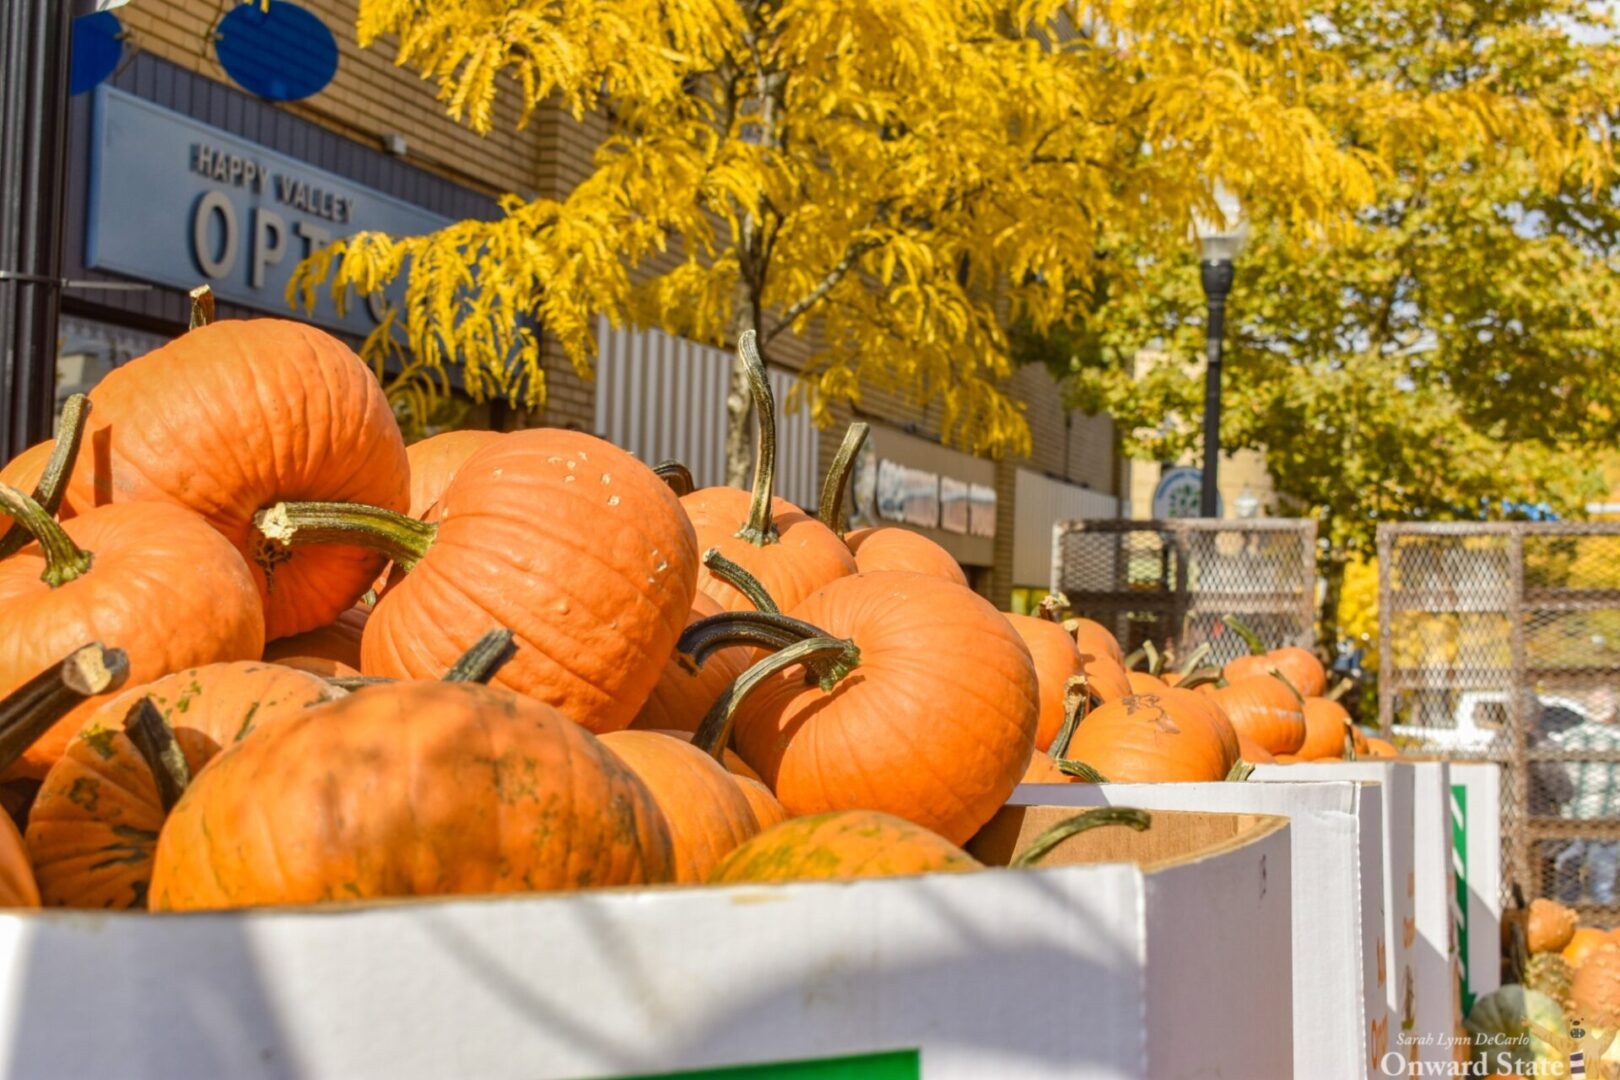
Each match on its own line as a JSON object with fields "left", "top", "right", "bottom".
{"left": 1011, "top": 780, "right": 1393, "bottom": 1080}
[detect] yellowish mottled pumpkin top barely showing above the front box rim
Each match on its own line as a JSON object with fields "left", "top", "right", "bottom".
{"left": 710, "top": 810, "right": 982, "bottom": 884}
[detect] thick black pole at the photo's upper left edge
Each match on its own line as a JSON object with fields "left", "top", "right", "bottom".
{"left": 0, "top": 0, "right": 73, "bottom": 461}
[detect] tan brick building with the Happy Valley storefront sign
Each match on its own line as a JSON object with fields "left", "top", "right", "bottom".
{"left": 58, "top": 0, "right": 1126, "bottom": 607}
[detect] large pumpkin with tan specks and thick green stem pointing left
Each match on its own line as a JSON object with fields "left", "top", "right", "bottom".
{"left": 261, "top": 427, "right": 698, "bottom": 732}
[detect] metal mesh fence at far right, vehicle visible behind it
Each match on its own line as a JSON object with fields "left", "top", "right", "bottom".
{"left": 1379, "top": 521, "right": 1620, "bottom": 918}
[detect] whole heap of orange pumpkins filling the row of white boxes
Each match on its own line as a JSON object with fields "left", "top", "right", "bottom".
{"left": 0, "top": 310, "right": 1354, "bottom": 910}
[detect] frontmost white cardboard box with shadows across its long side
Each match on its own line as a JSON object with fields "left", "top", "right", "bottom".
{"left": 0, "top": 811, "right": 1289, "bottom": 1080}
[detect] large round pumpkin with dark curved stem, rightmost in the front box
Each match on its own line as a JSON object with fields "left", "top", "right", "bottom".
{"left": 689, "top": 572, "right": 1040, "bottom": 842}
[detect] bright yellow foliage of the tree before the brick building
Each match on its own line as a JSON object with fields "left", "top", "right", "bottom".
{"left": 290, "top": 0, "right": 1607, "bottom": 478}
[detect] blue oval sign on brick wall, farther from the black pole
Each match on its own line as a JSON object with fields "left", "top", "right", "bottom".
{"left": 214, "top": 0, "right": 337, "bottom": 102}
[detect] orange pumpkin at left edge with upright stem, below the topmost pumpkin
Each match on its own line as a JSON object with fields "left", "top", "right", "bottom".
{"left": 0, "top": 489, "right": 264, "bottom": 779}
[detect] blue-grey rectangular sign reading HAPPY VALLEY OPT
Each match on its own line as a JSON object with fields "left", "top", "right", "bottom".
{"left": 84, "top": 86, "right": 450, "bottom": 335}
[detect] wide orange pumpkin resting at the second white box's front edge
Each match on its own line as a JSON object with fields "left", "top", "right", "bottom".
{"left": 1068, "top": 691, "right": 1231, "bottom": 784}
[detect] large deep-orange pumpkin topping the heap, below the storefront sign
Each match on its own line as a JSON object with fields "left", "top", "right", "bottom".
{"left": 68, "top": 319, "right": 410, "bottom": 640}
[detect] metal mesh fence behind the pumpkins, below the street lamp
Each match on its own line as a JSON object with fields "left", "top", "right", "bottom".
{"left": 1051, "top": 518, "right": 1315, "bottom": 664}
